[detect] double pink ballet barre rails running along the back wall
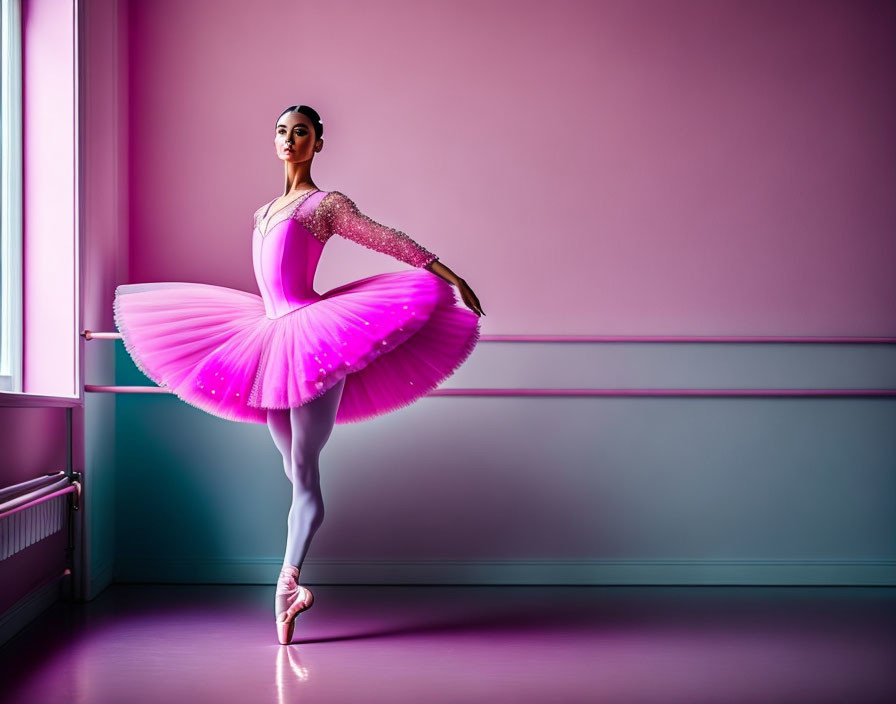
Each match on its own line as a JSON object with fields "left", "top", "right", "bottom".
{"left": 81, "top": 330, "right": 896, "bottom": 398}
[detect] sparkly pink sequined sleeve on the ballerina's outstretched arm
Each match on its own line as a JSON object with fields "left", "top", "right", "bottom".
{"left": 314, "top": 191, "right": 438, "bottom": 268}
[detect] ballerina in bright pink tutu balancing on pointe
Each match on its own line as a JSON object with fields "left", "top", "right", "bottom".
{"left": 113, "top": 105, "right": 484, "bottom": 644}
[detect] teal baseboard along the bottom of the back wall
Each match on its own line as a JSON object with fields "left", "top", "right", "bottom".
{"left": 108, "top": 558, "right": 896, "bottom": 586}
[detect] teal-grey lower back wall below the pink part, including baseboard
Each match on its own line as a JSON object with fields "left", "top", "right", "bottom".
{"left": 115, "top": 342, "right": 896, "bottom": 584}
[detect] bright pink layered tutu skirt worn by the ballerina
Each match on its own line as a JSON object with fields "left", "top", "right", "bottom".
{"left": 113, "top": 269, "right": 479, "bottom": 424}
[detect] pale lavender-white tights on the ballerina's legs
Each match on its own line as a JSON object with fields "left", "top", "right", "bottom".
{"left": 268, "top": 377, "right": 345, "bottom": 569}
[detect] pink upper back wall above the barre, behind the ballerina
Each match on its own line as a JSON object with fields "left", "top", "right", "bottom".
{"left": 129, "top": 0, "right": 896, "bottom": 335}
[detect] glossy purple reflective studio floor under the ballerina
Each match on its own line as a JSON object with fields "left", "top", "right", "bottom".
{"left": 0, "top": 584, "right": 896, "bottom": 704}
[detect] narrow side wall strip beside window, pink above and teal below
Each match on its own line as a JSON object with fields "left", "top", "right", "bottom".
{"left": 81, "top": 0, "right": 129, "bottom": 599}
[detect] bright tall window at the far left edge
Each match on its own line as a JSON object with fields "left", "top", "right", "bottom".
{"left": 0, "top": 0, "right": 22, "bottom": 392}
